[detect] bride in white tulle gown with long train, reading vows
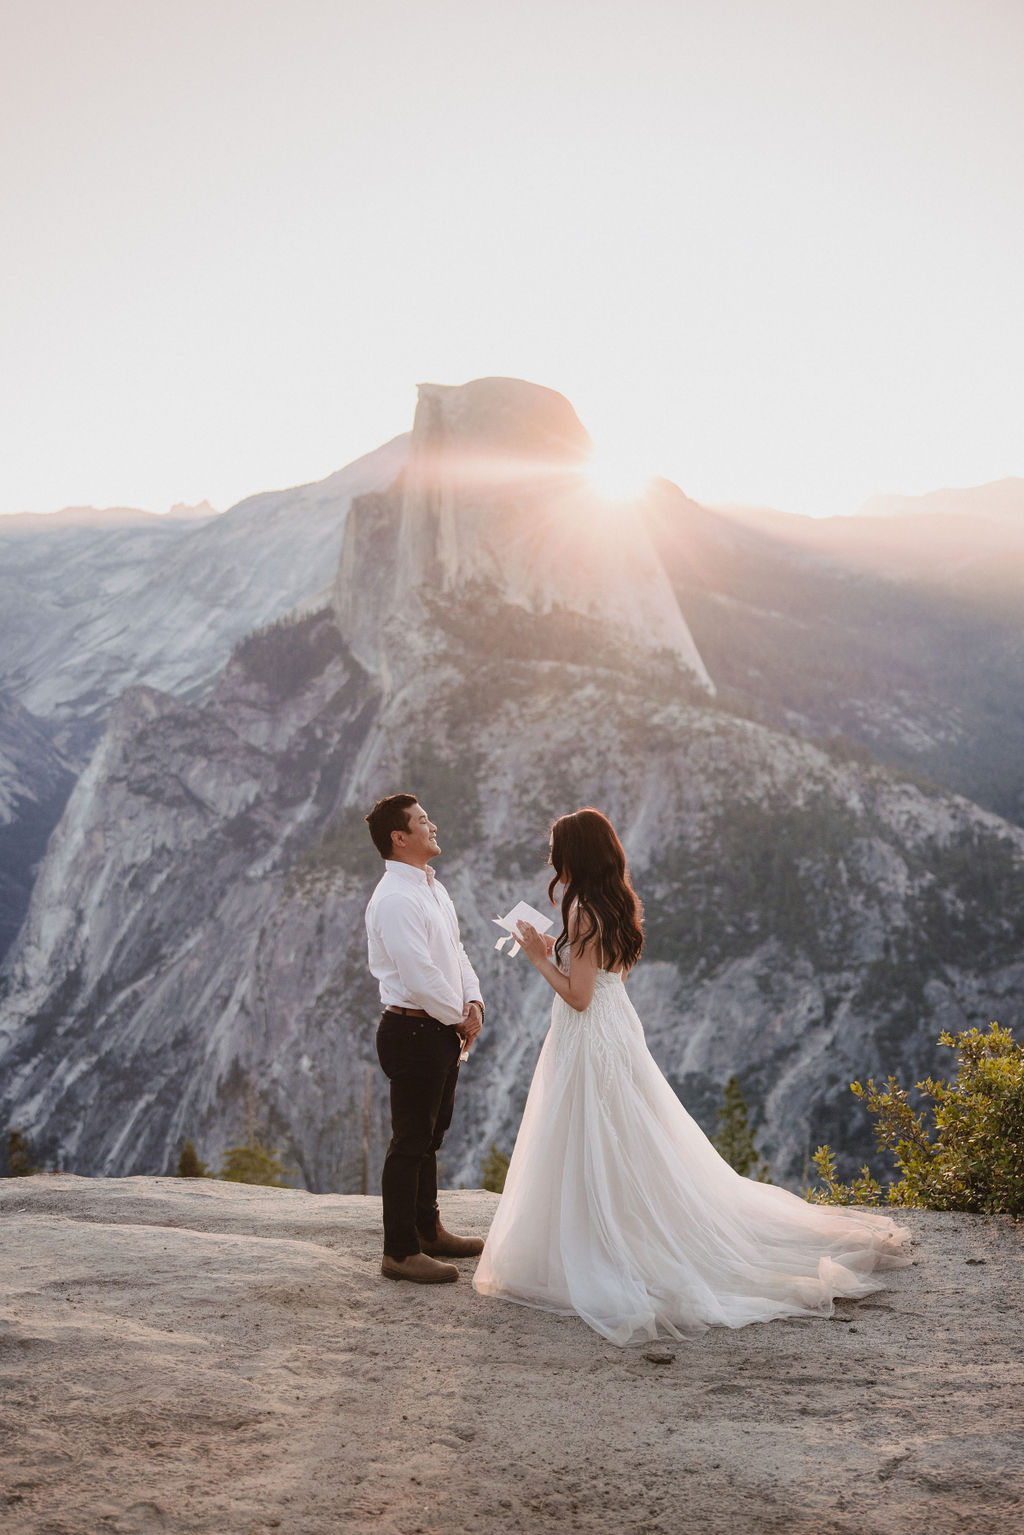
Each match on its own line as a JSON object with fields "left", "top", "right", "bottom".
{"left": 473, "top": 809, "right": 910, "bottom": 1345}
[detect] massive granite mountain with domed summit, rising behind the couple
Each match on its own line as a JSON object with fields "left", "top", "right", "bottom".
{"left": 0, "top": 381, "right": 1024, "bottom": 1191}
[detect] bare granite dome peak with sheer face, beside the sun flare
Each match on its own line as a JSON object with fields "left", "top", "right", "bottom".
{"left": 335, "top": 378, "right": 714, "bottom": 691}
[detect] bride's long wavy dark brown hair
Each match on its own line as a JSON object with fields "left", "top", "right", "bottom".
{"left": 548, "top": 806, "right": 643, "bottom": 970}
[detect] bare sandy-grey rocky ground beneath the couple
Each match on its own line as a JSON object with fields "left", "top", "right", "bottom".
{"left": 0, "top": 1176, "right": 1024, "bottom": 1535}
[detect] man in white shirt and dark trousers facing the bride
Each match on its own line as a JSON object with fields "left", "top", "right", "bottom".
{"left": 367, "top": 794, "right": 484, "bottom": 1285}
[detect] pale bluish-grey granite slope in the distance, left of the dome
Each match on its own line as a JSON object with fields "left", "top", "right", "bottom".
{"left": 0, "top": 436, "right": 408, "bottom": 958}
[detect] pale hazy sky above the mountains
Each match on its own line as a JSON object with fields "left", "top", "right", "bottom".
{"left": 0, "top": 0, "right": 1024, "bottom": 514}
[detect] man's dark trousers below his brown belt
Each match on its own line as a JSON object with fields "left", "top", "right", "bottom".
{"left": 376, "top": 1013, "right": 462, "bottom": 1262}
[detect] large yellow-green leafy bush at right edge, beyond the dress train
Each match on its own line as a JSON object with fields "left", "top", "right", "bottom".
{"left": 808, "top": 1024, "right": 1024, "bottom": 1216}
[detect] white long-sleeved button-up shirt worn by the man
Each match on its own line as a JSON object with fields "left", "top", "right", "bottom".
{"left": 367, "top": 858, "right": 482, "bottom": 1027}
